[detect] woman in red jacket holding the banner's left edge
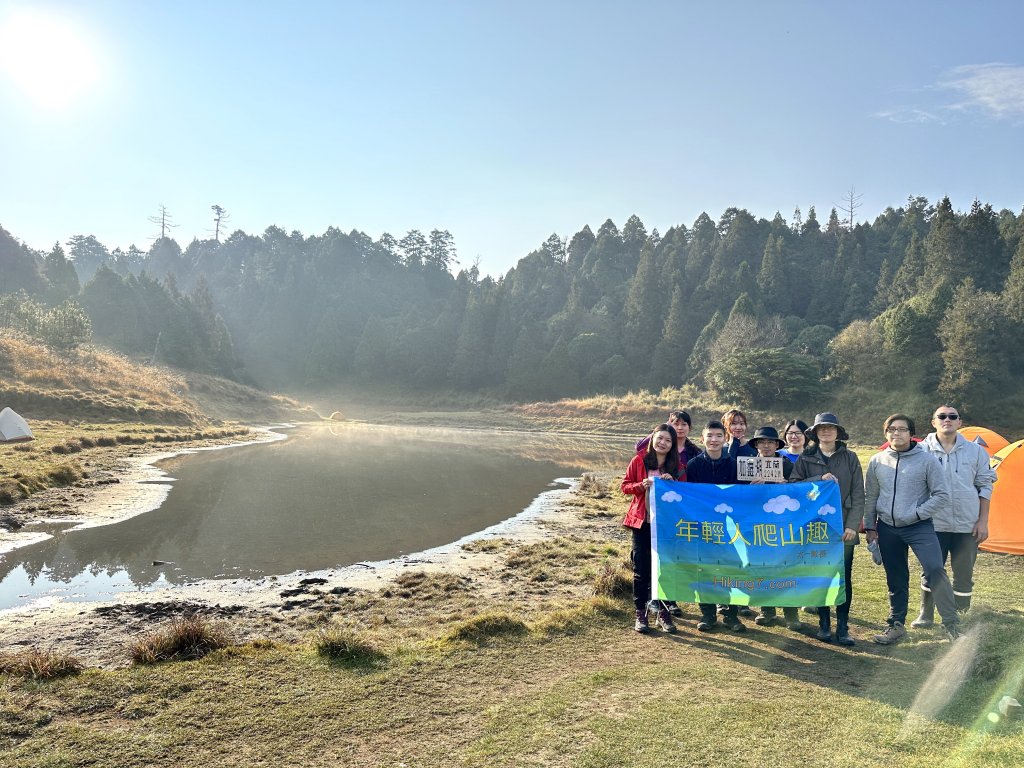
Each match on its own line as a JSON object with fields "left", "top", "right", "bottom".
{"left": 622, "top": 424, "right": 686, "bottom": 633}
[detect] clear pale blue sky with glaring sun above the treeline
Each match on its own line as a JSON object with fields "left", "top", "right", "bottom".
{"left": 0, "top": 0, "right": 1024, "bottom": 276}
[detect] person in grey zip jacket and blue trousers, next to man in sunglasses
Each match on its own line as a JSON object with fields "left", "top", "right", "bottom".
{"left": 864, "top": 414, "right": 959, "bottom": 645}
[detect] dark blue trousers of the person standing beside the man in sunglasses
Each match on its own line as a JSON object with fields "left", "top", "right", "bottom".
{"left": 878, "top": 520, "right": 959, "bottom": 627}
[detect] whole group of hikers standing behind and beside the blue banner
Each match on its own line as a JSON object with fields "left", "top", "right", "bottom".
{"left": 622, "top": 406, "right": 995, "bottom": 645}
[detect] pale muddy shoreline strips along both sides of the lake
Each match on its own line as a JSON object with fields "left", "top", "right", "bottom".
{"left": 0, "top": 427, "right": 598, "bottom": 668}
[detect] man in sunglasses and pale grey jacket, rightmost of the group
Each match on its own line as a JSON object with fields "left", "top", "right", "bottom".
{"left": 910, "top": 406, "right": 995, "bottom": 628}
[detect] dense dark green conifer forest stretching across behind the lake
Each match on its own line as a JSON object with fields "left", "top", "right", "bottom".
{"left": 0, "top": 197, "right": 1024, "bottom": 417}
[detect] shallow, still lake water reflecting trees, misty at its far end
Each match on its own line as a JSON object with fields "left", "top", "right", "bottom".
{"left": 0, "top": 425, "right": 630, "bottom": 610}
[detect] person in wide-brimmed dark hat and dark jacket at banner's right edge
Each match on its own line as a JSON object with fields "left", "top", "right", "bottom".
{"left": 790, "top": 412, "right": 864, "bottom": 645}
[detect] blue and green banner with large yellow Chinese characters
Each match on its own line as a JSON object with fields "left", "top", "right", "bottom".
{"left": 647, "top": 480, "right": 846, "bottom": 607}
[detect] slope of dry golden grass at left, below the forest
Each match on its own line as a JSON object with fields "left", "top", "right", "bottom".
{"left": 0, "top": 331, "right": 316, "bottom": 426}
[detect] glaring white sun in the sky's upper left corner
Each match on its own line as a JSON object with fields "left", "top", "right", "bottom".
{"left": 0, "top": 8, "right": 100, "bottom": 110}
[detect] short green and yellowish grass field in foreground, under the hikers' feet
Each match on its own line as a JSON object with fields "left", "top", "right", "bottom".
{"left": 0, "top": 477, "right": 1024, "bottom": 768}
